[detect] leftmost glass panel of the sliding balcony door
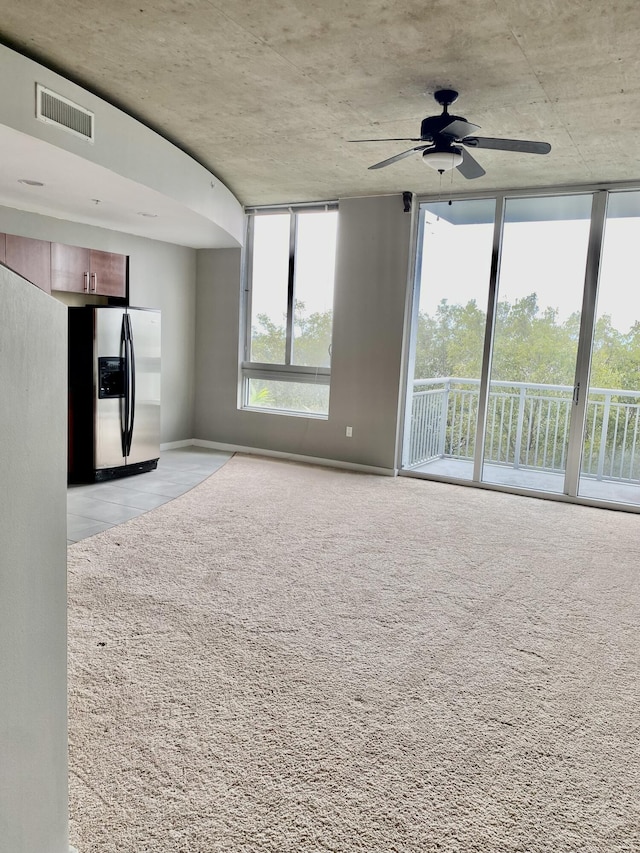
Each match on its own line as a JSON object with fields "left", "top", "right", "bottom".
{"left": 404, "top": 199, "right": 495, "bottom": 480}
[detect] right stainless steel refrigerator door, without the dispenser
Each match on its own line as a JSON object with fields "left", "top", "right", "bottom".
{"left": 127, "top": 308, "right": 160, "bottom": 465}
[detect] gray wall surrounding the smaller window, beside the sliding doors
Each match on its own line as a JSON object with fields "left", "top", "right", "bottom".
{"left": 194, "top": 195, "right": 411, "bottom": 469}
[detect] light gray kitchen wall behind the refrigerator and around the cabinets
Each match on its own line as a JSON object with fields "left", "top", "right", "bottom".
{"left": 0, "top": 207, "right": 196, "bottom": 443}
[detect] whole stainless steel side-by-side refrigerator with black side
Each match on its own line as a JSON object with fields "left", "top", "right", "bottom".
{"left": 68, "top": 305, "right": 160, "bottom": 483}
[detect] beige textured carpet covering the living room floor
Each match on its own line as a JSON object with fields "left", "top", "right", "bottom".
{"left": 69, "top": 456, "right": 640, "bottom": 853}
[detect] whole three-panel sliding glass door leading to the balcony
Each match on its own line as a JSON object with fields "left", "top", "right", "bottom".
{"left": 403, "top": 184, "right": 640, "bottom": 506}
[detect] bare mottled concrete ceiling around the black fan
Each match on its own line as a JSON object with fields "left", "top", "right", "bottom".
{"left": 0, "top": 0, "right": 640, "bottom": 204}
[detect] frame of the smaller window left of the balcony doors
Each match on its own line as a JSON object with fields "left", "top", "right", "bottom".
{"left": 238, "top": 201, "right": 338, "bottom": 412}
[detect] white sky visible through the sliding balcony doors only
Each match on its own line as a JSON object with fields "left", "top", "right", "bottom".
{"left": 420, "top": 213, "right": 640, "bottom": 332}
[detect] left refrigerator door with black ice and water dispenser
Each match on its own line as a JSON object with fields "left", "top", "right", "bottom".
{"left": 93, "top": 308, "right": 125, "bottom": 469}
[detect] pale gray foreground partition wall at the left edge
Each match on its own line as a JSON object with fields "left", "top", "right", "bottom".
{"left": 0, "top": 265, "right": 68, "bottom": 853}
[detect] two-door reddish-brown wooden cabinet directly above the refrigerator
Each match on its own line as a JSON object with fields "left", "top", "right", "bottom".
{"left": 51, "top": 243, "right": 127, "bottom": 298}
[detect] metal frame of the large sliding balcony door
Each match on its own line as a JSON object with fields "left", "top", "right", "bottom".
{"left": 397, "top": 181, "right": 640, "bottom": 512}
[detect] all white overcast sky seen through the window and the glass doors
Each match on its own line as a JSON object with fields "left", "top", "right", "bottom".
{"left": 253, "top": 205, "right": 640, "bottom": 332}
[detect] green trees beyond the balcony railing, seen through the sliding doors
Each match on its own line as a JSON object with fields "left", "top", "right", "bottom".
{"left": 414, "top": 293, "right": 640, "bottom": 476}
